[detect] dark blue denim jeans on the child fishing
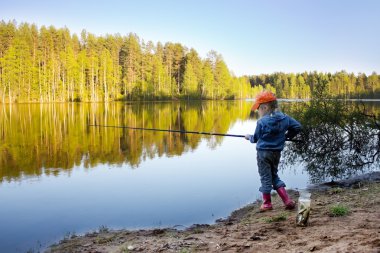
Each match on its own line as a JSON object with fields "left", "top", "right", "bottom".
{"left": 257, "top": 150, "right": 285, "bottom": 193}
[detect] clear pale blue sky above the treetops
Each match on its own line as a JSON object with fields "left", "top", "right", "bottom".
{"left": 0, "top": 0, "right": 380, "bottom": 76}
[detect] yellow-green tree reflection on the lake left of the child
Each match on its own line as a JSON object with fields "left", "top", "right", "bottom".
{"left": 0, "top": 101, "right": 251, "bottom": 182}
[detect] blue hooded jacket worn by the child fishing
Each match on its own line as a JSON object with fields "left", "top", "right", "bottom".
{"left": 250, "top": 112, "right": 301, "bottom": 151}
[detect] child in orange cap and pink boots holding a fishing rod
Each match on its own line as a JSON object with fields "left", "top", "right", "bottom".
{"left": 245, "top": 91, "right": 301, "bottom": 212}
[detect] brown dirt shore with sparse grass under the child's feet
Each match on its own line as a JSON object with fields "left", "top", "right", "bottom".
{"left": 47, "top": 173, "right": 380, "bottom": 253}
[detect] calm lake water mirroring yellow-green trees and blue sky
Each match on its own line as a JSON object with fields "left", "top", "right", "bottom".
{"left": 0, "top": 101, "right": 368, "bottom": 252}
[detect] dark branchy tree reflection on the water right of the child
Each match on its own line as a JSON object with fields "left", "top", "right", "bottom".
{"left": 283, "top": 98, "right": 380, "bottom": 182}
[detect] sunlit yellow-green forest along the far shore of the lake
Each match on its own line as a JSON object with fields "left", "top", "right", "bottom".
{"left": 0, "top": 21, "right": 380, "bottom": 103}
